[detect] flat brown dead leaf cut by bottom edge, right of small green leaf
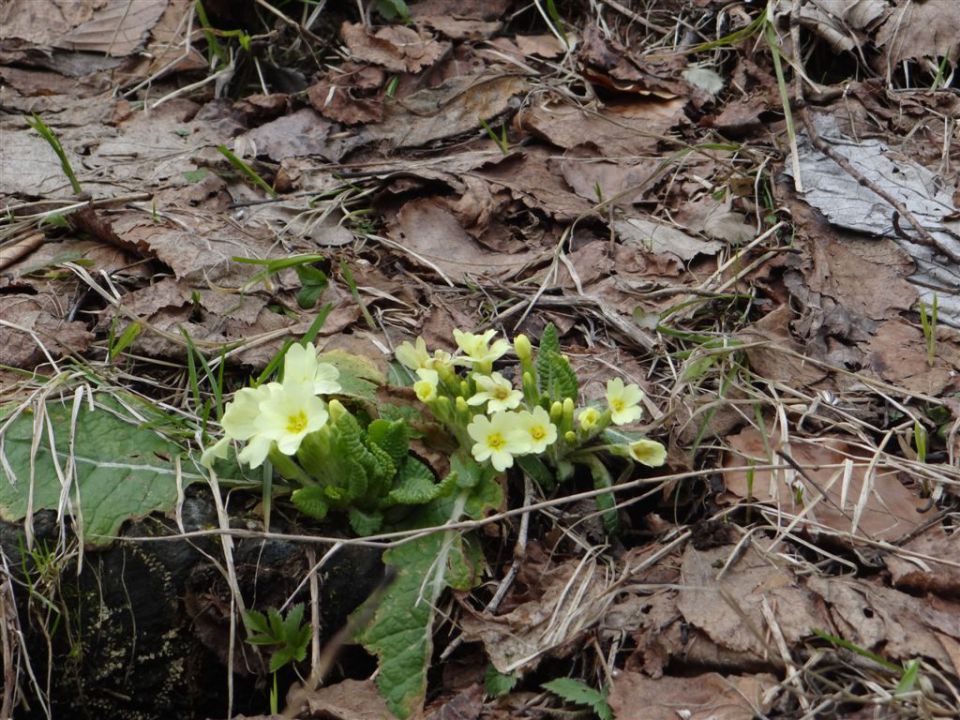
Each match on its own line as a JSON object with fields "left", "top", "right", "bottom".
{"left": 608, "top": 671, "right": 777, "bottom": 720}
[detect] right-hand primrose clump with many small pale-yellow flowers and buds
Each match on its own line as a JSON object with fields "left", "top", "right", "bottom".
{"left": 396, "top": 324, "right": 666, "bottom": 530}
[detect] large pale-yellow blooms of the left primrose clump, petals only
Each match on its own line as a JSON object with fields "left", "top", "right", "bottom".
{"left": 200, "top": 343, "right": 340, "bottom": 468}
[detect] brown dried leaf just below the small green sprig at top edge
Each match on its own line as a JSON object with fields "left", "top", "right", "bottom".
{"left": 340, "top": 22, "right": 450, "bottom": 73}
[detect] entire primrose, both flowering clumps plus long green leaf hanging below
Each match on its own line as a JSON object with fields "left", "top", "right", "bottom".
{"left": 202, "top": 325, "right": 666, "bottom": 718}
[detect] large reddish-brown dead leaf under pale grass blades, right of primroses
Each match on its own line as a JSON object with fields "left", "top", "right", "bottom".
{"left": 724, "top": 427, "right": 927, "bottom": 540}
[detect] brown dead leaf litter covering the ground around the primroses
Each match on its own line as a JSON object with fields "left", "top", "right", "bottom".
{"left": 0, "top": 0, "right": 960, "bottom": 720}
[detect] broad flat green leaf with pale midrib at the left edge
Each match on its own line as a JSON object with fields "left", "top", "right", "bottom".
{"left": 0, "top": 395, "right": 202, "bottom": 545}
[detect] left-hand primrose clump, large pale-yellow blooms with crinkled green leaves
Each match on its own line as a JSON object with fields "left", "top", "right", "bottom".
{"left": 201, "top": 343, "right": 443, "bottom": 535}
